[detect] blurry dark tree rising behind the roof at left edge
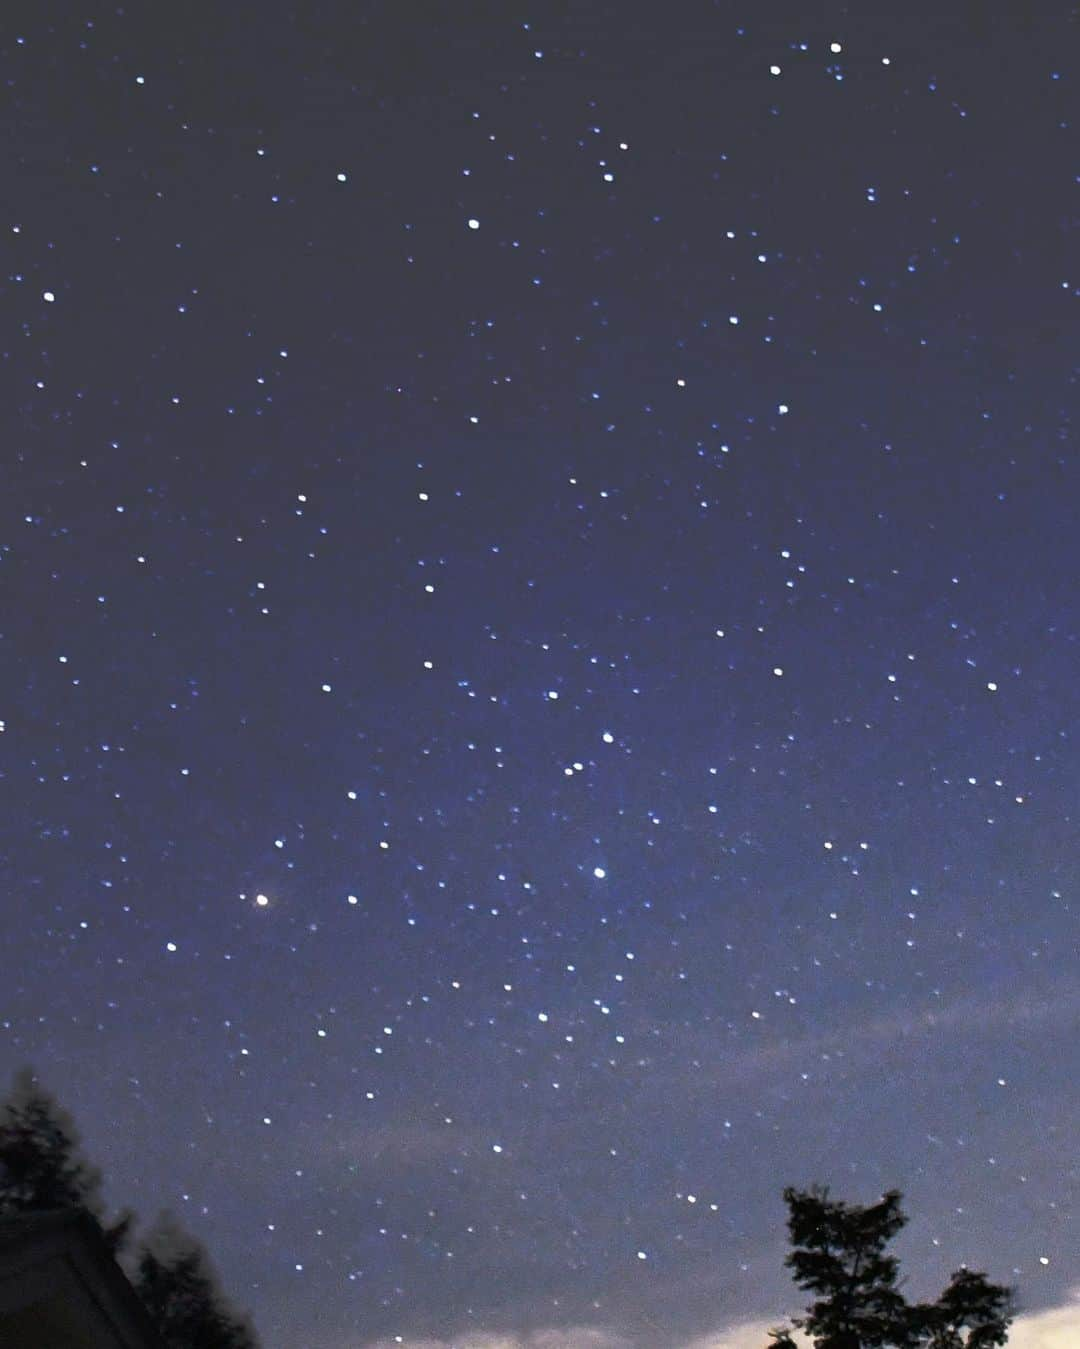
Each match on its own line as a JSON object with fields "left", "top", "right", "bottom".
{"left": 0, "top": 1068, "right": 132, "bottom": 1252}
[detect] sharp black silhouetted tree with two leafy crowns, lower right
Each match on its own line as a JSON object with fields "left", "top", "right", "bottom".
{"left": 770, "top": 1186, "right": 1013, "bottom": 1349}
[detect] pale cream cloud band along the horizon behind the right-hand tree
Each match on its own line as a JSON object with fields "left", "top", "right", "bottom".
{"left": 355, "top": 1287, "right": 1080, "bottom": 1349}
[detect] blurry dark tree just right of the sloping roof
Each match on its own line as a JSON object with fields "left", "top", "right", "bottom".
{"left": 133, "top": 1214, "right": 259, "bottom": 1349}
